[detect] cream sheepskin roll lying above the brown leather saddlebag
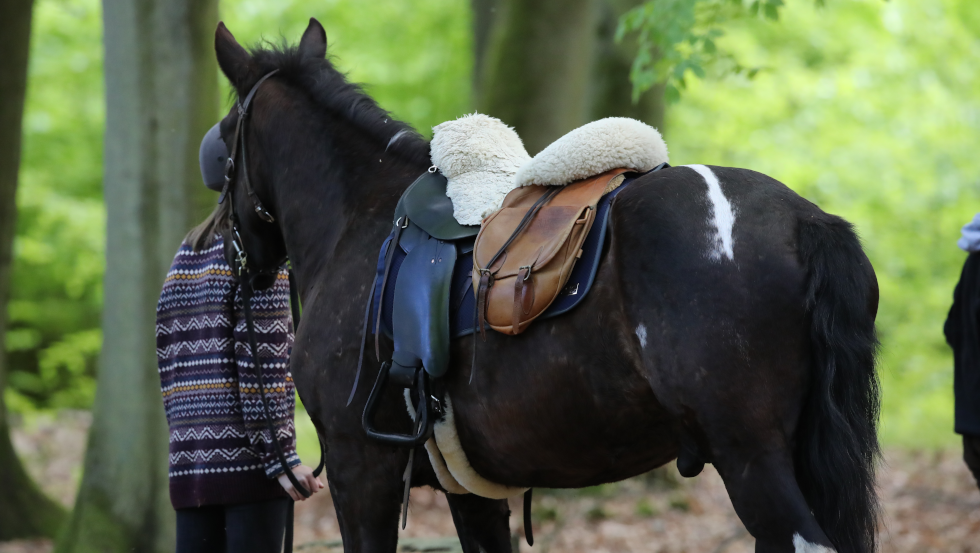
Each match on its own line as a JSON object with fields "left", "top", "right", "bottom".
{"left": 517, "top": 117, "right": 669, "bottom": 186}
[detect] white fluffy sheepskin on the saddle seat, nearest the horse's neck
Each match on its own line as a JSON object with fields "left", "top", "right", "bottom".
{"left": 430, "top": 113, "right": 531, "bottom": 225}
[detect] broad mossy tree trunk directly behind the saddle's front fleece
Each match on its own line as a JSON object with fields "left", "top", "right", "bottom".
{"left": 476, "top": 0, "right": 597, "bottom": 155}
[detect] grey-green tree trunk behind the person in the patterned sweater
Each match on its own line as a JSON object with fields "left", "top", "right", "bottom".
{"left": 57, "top": 0, "right": 218, "bottom": 552}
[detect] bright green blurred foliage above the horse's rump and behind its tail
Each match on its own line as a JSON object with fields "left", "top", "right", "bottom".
{"left": 667, "top": 0, "right": 980, "bottom": 445}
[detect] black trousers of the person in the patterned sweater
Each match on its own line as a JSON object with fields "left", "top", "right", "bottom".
{"left": 177, "top": 497, "right": 293, "bottom": 553}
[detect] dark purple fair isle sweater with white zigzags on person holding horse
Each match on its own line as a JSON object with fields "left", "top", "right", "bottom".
{"left": 156, "top": 238, "right": 300, "bottom": 509}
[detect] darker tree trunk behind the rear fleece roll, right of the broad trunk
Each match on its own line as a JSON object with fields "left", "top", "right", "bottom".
{"left": 590, "top": 0, "right": 664, "bottom": 133}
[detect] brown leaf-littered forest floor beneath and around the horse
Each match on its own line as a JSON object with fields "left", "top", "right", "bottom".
{"left": 0, "top": 412, "right": 980, "bottom": 553}
